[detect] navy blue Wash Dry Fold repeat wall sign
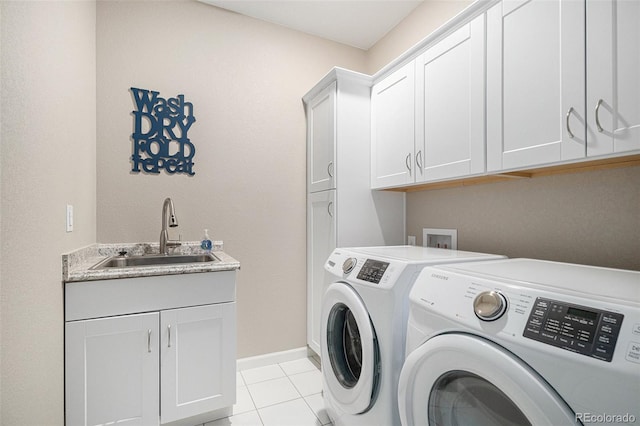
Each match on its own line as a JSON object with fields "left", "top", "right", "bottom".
{"left": 131, "top": 87, "right": 196, "bottom": 176}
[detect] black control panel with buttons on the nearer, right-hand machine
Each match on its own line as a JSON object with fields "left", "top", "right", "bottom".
{"left": 523, "top": 297, "right": 624, "bottom": 362}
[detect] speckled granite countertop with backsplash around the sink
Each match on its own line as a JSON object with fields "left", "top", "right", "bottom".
{"left": 62, "top": 241, "right": 240, "bottom": 282}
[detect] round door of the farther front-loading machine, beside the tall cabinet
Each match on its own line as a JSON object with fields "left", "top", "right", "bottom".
{"left": 321, "top": 282, "right": 380, "bottom": 414}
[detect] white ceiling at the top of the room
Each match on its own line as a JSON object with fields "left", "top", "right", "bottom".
{"left": 200, "top": 0, "right": 423, "bottom": 50}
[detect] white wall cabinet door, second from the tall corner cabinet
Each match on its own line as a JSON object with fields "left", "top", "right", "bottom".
{"left": 416, "top": 15, "right": 485, "bottom": 181}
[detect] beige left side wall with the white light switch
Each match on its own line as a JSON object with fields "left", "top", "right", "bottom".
{"left": 0, "top": 1, "right": 96, "bottom": 425}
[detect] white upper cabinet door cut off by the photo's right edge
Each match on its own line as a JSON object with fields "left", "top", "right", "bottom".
{"left": 587, "top": 0, "right": 640, "bottom": 155}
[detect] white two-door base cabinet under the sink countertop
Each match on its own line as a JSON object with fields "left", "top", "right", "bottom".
{"left": 65, "top": 271, "right": 236, "bottom": 426}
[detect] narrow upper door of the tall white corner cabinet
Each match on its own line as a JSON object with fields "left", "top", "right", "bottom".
{"left": 307, "top": 82, "right": 336, "bottom": 192}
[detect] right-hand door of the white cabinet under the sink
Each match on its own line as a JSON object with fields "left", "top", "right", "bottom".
{"left": 160, "top": 302, "right": 236, "bottom": 424}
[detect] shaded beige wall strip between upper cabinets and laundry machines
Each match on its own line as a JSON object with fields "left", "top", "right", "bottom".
{"left": 407, "top": 167, "right": 640, "bottom": 270}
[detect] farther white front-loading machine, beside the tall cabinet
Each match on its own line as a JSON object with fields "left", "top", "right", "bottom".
{"left": 320, "top": 246, "right": 504, "bottom": 426}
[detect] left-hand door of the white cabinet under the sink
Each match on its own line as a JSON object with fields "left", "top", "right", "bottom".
{"left": 65, "top": 312, "right": 160, "bottom": 426}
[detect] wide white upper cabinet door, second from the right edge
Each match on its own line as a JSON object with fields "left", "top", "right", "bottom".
{"left": 487, "top": 0, "right": 586, "bottom": 171}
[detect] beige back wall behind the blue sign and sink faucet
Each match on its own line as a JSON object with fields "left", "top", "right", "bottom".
{"left": 97, "top": 1, "right": 365, "bottom": 357}
